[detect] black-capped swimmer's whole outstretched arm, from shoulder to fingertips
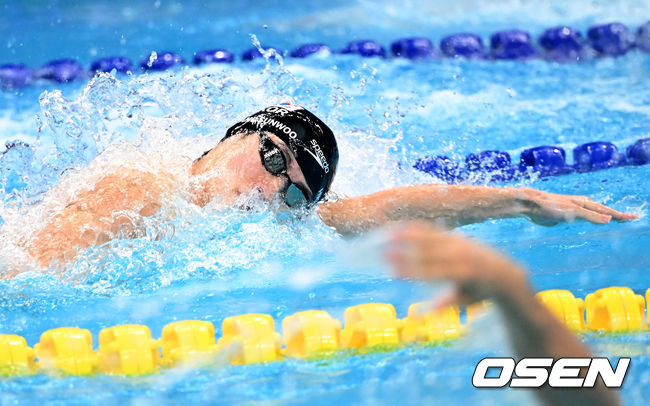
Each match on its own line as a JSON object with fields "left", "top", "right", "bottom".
{"left": 318, "top": 185, "right": 636, "bottom": 234}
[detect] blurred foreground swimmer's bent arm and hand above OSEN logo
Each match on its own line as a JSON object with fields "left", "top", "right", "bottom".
{"left": 387, "top": 223, "right": 620, "bottom": 406}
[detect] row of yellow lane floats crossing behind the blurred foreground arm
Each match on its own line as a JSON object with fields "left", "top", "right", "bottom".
{"left": 0, "top": 287, "right": 650, "bottom": 376}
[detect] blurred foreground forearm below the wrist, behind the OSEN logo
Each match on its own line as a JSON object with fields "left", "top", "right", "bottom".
{"left": 495, "top": 288, "right": 620, "bottom": 405}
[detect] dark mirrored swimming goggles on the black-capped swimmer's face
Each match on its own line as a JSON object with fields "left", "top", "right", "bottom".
{"left": 260, "top": 134, "right": 311, "bottom": 207}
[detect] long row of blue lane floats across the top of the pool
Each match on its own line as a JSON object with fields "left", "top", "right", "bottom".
{"left": 0, "top": 21, "right": 650, "bottom": 89}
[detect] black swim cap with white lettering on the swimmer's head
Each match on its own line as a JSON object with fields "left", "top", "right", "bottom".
{"left": 221, "top": 103, "right": 339, "bottom": 203}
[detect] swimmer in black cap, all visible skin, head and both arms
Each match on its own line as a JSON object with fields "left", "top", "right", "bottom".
{"left": 17, "top": 104, "right": 636, "bottom": 277}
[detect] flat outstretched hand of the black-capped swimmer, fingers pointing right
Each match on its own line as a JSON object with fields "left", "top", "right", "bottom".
{"left": 516, "top": 188, "right": 637, "bottom": 226}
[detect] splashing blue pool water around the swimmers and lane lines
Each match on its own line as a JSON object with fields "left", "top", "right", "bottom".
{"left": 0, "top": 1, "right": 650, "bottom": 405}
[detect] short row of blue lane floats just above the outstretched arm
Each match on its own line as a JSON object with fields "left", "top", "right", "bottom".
{"left": 413, "top": 138, "right": 650, "bottom": 184}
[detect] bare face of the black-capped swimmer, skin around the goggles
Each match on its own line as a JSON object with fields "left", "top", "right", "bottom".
{"left": 215, "top": 133, "right": 307, "bottom": 205}
